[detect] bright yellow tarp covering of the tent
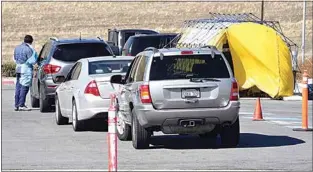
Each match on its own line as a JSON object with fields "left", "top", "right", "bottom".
{"left": 207, "top": 23, "right": 294, "bottom": 98}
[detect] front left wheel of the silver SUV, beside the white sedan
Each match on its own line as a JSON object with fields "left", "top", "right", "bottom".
{"left": 116, "top": 111, "right": 132, "bottom": 141}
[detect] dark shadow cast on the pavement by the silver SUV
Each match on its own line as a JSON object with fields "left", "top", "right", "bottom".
{"left": 150, "top": 133, "right": 305, "bottom": 149}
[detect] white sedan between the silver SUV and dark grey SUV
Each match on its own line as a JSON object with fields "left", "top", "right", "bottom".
{"left": 55, "top": 56, "right": 134, "bottom": 131}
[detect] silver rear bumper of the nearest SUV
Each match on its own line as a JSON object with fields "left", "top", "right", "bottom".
{"left": 134, "top": 101, "right": 240, "bottom": 128}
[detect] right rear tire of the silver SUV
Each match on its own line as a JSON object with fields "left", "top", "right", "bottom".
{"left": 220, "top": 117, "right": 240, "bottom": 148}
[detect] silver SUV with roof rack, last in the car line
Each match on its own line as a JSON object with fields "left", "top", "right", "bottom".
{"left": 111, "top": 47, "right": 240, "bottom": 149}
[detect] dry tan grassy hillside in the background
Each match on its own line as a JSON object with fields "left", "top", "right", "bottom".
{"left": 2, "top": 2, "right": 313, "bottom": 61}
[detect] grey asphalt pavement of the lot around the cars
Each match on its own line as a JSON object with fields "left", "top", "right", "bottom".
{"left": 1, "top": 86, "right": 312, "bottom": 171}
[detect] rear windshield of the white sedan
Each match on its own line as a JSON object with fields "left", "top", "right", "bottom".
{"left": 89, "top": 60, "right": 131, "bottom": 75}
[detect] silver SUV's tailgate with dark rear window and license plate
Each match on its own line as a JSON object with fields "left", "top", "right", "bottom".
{"left": 149, "top": 55, "right": 232, "bottom": 109}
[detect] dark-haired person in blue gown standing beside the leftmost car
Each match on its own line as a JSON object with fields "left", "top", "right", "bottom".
{"left": 14, "top": 35, "right": 33, "bottom": 111}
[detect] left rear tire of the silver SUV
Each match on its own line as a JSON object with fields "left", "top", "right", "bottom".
{"left": 131, "top": 109, "right": 151, "bottom": 149}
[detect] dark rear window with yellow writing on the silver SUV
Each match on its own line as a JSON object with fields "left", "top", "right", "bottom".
{"left": 150, "top": 54, "right": 230, "bottom": 81}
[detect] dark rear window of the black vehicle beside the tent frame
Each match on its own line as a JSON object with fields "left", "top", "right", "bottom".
{"left": 131, "top": 35, "right": 175, "bottom": 55}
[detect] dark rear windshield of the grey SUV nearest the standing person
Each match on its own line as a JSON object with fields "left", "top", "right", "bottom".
{"left": 53, "top": 43, "right": 111, "bottom": 62}
